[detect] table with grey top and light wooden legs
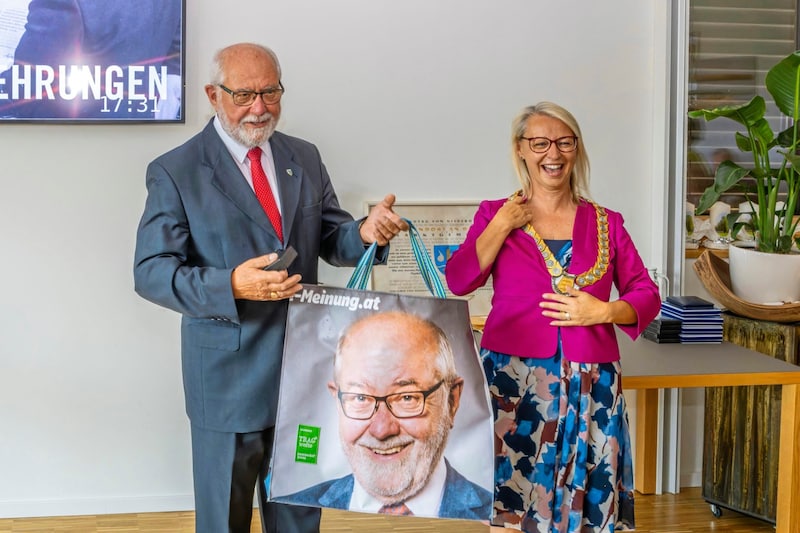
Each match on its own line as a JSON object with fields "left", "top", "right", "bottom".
{"left": 617, "top": 333, "right": 800, "bottom": 533}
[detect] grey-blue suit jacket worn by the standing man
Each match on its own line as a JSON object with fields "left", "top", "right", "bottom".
{"left": 134, "top": 122, "right": 380, "bottom": 432}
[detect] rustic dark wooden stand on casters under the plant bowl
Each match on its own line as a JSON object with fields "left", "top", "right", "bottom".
{"left": 703, "top": 313, "right": 800, "bottom": 523}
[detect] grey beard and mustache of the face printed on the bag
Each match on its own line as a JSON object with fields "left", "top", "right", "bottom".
{"left": 342, "top": 416, "right": 450, "bottom": 504}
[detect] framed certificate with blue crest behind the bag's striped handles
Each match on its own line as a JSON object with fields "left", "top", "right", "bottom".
{"left": 365, "top": 201, "right": 492, "bottom": 316}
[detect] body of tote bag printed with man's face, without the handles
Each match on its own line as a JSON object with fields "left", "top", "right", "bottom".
{"left": 267, "top": 285, "right": 493, "bottom": 520}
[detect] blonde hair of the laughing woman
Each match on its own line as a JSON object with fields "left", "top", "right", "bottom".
{"left": 511, "top": 102, "right": 589, "bottom": 203}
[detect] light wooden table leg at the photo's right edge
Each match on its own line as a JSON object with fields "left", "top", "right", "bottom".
{"left": 776, "top": 385, "right": 800, "bottom": 533}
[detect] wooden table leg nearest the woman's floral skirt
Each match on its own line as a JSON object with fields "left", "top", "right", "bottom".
{"left": 633, "top": 389, "right": 658, "bottom": 494}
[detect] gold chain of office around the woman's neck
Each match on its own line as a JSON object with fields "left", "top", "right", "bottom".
{"left": 517, "top": 193, "right": 608, "bottom": 295}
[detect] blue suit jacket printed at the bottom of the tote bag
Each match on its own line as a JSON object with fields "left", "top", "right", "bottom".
{"left": 282, "top": 460, "right": 492, "bottom": 520}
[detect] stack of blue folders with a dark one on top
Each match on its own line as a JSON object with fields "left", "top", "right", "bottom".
{"left": 661, "top": 296, "right": 722, "bottom": 344}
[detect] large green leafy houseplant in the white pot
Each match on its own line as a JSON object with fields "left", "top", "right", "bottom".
{"left": 689, "top": 50, "right": 800, "bottom": 254}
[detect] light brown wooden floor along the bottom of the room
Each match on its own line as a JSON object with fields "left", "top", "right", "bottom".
{"left": 0, "top": 488, "right": 775, "bottom": 533}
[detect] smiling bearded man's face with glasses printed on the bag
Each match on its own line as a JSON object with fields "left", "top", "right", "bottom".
{"left": 329, "top": 312, "right": 463, "bottom": 503}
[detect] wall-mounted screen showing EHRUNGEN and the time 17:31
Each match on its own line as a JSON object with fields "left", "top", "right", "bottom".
{"left": 0, "top": 0, "right": 185, "bottom": 123}
